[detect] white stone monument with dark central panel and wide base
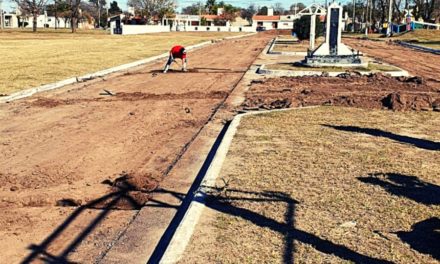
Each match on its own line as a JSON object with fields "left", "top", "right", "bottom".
{"left": 303, "top": 3, "right": 365, "bottom": 67}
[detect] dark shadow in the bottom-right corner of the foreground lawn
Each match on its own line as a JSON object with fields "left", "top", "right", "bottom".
{"left": 396, "top": 217, "right": 440, "bottom": 260}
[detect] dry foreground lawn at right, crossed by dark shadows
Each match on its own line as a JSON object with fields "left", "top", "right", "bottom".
{"left": 181, "top": 107, "right": 440, "bottom": 263}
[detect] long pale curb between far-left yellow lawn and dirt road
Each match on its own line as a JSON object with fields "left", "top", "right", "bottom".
{"left": 0, "top": 33, "right": 257, "bottom": 103}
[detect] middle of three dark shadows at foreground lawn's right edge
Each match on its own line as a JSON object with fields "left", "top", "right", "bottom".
{"left": 357, "top": 173, "right": 440, "bottom": 205}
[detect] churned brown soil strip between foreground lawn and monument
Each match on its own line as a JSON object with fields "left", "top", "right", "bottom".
{"left": 243, "top": 73, "right": 440, "bottom": 111}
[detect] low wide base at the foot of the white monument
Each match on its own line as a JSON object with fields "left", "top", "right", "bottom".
{"left": 302, "top": 54, "right": 368, "bottom": 67}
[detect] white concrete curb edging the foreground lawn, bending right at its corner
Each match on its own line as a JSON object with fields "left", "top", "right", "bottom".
{"left": 159, "top": 106, "right": 320, "bottom": 264}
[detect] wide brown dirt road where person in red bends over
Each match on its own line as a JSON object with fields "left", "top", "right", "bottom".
{"left": 0, "top": 34, "right": 269, "bottom": 263}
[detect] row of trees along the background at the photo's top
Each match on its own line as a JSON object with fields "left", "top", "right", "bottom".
{"left": 14, "top": 0, "right": 440, "bottom": 32}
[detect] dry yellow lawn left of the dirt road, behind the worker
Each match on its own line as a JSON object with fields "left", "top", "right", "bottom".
{"left": 0, "top": 29, "right": 243, "bottom": 94}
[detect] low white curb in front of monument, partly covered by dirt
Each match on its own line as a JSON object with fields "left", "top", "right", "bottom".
{"left": 257, "top": 64, "right": 409, "bottom": 77}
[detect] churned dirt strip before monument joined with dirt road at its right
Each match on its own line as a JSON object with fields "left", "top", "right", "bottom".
{"left": 243, "top": 39, "right": 440, "bottom": 110}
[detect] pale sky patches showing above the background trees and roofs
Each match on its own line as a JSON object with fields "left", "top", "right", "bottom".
{"left": 3, "top": 0, "right": 347, "bottom": 11}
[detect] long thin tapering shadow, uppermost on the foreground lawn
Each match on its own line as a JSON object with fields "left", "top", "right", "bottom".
{"left": 322, "top": 124, "right": 440, "bottom": 150}
